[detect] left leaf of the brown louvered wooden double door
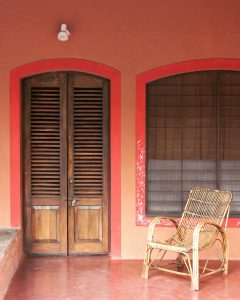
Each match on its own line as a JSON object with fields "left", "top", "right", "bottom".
{"left": 23, "top": 74, "right": 67, "bottom": 254}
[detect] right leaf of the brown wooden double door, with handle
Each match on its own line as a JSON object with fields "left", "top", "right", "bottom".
{"left": 69, "top": 74, "right": 108, "bottom": 254}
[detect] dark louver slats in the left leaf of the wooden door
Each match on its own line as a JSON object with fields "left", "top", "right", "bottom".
{"left": 31, "top": 87, "right": 60, "bottom": 198}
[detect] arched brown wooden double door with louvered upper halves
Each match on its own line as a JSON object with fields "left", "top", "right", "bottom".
{"left": 22, "top": 72, "right": 109, "bottom": 255}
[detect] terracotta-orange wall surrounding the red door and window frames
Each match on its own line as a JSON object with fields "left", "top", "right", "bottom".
{"left": 0, "top": 0, "right": 240, "bottom": 258}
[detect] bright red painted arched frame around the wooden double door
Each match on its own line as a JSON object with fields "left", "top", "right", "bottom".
{"left": 9, "top": 58, "right": 121, "bottom": 258}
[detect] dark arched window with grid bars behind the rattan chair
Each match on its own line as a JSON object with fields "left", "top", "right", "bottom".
{"left": 146, "top": 71, "right": 240, "bottom": 217}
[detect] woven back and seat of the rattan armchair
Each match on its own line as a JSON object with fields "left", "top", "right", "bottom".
{"left": 176, "top": 187, "right": 232, "bottom": 248}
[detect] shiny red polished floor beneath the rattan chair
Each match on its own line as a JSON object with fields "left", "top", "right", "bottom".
{"left": 4, "top": 256, "right": 240, "bottom": 300}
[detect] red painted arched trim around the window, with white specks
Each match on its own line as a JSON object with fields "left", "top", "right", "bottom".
{"left": 136, "top": 59, "right": 240, "bottom": 227}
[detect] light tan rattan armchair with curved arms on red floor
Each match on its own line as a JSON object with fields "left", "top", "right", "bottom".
{"left": 142, "top": 187, "right": 232, "bottom": 290}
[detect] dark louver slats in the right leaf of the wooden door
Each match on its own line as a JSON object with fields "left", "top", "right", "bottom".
{"left": 74, "top": 87, "right": 103, "bottom": 198}
